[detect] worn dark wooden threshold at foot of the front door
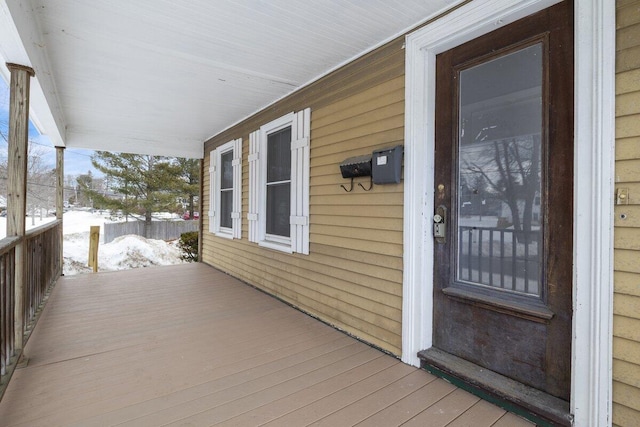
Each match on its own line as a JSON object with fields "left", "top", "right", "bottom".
{"left": 418, "top": 347, "right": 573, "bottom": 426}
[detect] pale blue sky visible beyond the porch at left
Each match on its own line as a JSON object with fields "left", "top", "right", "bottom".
{"left": 0, "top": 78, "right": 101, "bottom": 176}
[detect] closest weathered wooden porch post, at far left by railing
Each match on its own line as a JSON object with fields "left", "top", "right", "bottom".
{"left": 7, "top": 63, "right": 34, "bottom": 350}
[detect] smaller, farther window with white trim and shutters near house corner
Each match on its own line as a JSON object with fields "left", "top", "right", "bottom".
{"left": 209, "top": 139, "right": 242, "bottom": 239}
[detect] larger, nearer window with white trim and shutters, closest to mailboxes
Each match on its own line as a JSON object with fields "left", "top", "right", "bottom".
{"left": 247, "top": 108, "right": 311, "bottom": 254}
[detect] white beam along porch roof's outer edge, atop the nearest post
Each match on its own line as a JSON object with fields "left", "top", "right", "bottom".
{"left": 0, "top": 0, "right": 66, "bottom": 146}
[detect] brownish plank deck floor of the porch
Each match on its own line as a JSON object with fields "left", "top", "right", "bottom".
{"left": 0, "top": 264, "right": 530, "bottom": 427}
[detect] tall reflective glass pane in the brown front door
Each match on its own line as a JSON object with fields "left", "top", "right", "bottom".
{"left": 455, "top": 44, "right": 544, "bottom": 296}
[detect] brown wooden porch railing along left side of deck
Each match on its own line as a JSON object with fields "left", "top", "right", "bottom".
{"left": 0, "top": 220, "right": 62, "bottom": 398}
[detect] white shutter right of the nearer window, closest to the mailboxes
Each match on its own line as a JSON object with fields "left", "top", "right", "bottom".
{"left": 289, "top": 108, "right": 311, "bottom": 255}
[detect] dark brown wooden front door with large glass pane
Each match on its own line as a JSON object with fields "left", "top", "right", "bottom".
{"left": 434, "top": 2, "right": 573, "bottom": 400}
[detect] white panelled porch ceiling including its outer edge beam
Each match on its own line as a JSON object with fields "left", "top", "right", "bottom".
{"left": 0, "top": 0, "right": 460, "bottom": 158}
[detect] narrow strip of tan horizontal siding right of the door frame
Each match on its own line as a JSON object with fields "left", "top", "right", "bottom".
{"left": 613, "top": 0, "right": 640, "bottom": 426}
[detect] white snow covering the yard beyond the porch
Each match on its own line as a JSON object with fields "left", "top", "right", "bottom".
{"left": 0, "top": 211, "right": 184, "bottom": 276}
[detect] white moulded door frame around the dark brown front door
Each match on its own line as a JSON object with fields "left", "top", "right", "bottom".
{"left": 402, "top": 0, "right": 615, "bottom": 426}
